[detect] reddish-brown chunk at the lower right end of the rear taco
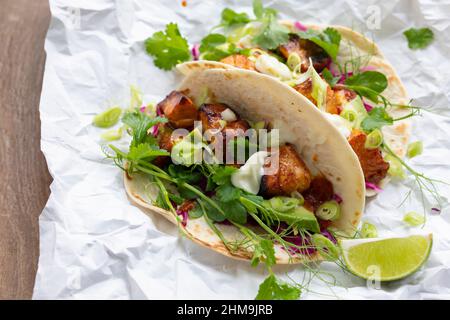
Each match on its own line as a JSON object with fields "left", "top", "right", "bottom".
{"left": 348, "top": 130, "right": 389, "bottom": 185}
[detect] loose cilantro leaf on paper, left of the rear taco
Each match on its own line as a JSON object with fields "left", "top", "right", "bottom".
{"left": 145, "top": 23, "right": 191, "bottom": 70}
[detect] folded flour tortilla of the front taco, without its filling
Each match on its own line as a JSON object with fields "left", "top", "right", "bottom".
{"left": 124, "top": 68, "right": 365, "bottom": 264}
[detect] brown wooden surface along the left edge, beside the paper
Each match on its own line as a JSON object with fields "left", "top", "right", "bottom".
{"left": 0, "top": 0, "right": 51, "bottom": 299}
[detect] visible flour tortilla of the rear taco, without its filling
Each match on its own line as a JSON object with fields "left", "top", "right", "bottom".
{"left": 177, "top": 21, "right": 411, "bottom": 196}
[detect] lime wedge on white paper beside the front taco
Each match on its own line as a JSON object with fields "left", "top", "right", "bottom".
{"left": 339, "top": 234, "right": 433, "bottom": 281}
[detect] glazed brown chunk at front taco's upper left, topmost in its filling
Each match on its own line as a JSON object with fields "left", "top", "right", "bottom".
{"left": 157, "top": 91, "right": 198, "bottom": 129}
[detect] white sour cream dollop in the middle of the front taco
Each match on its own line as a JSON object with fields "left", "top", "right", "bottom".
{"left": 231, "top": 151, "right": 269, "bottom": 194}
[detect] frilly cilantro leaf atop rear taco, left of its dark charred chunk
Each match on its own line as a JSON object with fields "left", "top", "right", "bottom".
{"left": 253, "top": 9, "right": 289, "bottom": 50}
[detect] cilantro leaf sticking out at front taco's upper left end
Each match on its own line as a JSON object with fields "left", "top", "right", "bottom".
{"left": 122, "top": 111, "right": 167, "bottom": 146}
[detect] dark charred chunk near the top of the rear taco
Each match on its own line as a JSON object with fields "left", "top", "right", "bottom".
{"left": 278, "top": 35, "right": 331, "bottom": 72}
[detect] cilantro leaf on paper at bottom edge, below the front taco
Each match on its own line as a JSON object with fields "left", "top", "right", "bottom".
{"left": 256, "top": 273, "right": 301, "bottom": 300}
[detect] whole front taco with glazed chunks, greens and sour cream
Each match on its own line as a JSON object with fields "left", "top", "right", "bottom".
{"left": 112, "top": 69, "right": 365, "bottom": 264}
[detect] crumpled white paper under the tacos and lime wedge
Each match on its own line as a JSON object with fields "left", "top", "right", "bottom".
{"left": 34, "top": 0, "right": 450, "bottom": 299}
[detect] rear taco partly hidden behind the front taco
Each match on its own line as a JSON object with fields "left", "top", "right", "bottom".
{"left": 149, "top": 1, "right": 418, "bottom": 195}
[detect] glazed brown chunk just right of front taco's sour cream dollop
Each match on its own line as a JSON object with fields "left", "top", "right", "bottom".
{"left": 261, "top": 144, "right": 311, "bottom": 197}
